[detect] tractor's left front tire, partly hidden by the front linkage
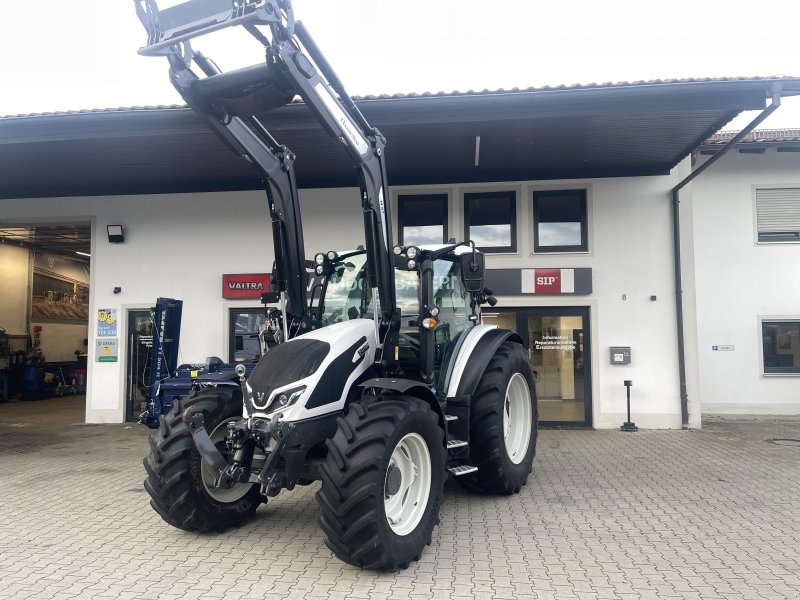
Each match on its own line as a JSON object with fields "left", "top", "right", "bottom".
{"left": 144, "top": 387, "right": 265, "bottom": 532}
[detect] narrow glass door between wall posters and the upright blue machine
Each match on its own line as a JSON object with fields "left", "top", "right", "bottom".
{"left": 125, "top": 310, "right": 153, "bottom": 421}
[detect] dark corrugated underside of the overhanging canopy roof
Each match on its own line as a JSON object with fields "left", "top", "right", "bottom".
{"left": 0, "top": 78, "right": 800, "bottom": 198}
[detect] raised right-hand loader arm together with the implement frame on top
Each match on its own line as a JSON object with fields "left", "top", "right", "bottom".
{"left": 135, "top": 0, "right": 398, "bottom": 343}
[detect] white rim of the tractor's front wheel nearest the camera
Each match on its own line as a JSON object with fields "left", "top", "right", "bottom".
{"left": 383, "top": 433, "right": 431, "bottom": 535}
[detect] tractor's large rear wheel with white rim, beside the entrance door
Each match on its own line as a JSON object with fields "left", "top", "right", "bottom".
{"left": 458, "top": 342, "right": 539, "bottom": 495}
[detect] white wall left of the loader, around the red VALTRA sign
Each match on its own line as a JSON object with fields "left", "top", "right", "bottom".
{"left": 0, "top": 189, "right": 363, "bottom": 422}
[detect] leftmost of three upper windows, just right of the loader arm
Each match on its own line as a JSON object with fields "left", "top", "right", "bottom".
{"left": 397, "top": 194, "right": 447, "bottom": 246}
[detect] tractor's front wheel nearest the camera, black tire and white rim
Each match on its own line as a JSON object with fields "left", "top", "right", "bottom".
{"left": 317, "top": 394, "right": 447, "bottom": 571}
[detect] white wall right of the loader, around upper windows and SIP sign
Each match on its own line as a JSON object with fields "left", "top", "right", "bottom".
{"left": 393, "top": 173, "right": 688, "bottom": 428}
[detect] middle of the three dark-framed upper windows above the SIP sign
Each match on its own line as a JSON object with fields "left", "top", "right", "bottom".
{"left": 464, "top": 192, "right": 517, "bottom": 252}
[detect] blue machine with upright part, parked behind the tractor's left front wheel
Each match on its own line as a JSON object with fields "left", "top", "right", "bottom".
{"left": 138, "top": 298, "right": 256, "bottom": 429}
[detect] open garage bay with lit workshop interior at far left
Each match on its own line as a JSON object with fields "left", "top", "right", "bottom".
{"left": 0, "top": 222, "right": 91, "bottom": 423}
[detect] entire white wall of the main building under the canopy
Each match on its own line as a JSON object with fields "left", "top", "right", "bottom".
{"left": 3, "top": 175, "right": 681, "bottom": 428}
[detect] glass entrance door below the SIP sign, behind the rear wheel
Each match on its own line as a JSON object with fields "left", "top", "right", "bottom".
{"left": 483, "top": 307, "right": 592, "bottom": 426}
